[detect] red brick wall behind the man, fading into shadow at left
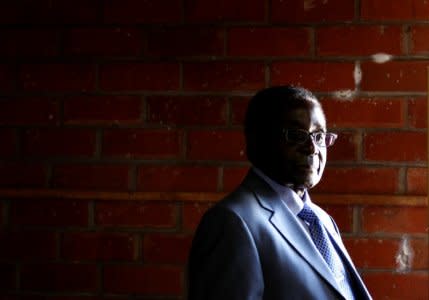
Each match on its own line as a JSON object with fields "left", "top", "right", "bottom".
{"left": 0, "top": 0, "right": 429, "bottom": 300}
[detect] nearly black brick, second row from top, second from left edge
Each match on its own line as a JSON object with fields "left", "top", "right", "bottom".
{"left": 64, "top": 27, "right": 143, "bottom": 56}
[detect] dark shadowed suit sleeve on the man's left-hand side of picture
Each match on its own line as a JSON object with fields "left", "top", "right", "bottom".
{"left": 188, "top": 207, "right": 264, "bottom": 300}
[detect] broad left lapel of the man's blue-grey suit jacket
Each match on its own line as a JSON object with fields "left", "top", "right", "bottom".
{"left": 243, "top": 171, "right": 341, "bottom": 294}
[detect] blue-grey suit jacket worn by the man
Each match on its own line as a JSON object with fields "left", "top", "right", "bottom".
{"left": 188, "top": 171, "right": 371, "bottom": 300}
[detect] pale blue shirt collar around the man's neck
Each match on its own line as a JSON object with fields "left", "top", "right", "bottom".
{"left": 252, "top": 166, "right": 311, "bottom": 215}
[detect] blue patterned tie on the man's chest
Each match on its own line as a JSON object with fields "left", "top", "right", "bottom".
{"left": 298, "top": 204, "right": 354, "bottom": 299}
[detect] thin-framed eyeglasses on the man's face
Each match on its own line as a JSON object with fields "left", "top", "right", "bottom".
{"left": 283, "top": 129, "right": 338, "bottom": 147}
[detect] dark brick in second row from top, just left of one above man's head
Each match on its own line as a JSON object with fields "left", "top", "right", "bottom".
{"left": 148, "top": 26, "right": 225, "bottom": 57}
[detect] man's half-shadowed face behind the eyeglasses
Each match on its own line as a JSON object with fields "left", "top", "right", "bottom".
{"left": 273, "top": 105, "right": 326, "bottom": 189}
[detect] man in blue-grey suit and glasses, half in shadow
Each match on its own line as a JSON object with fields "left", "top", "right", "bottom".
{"left": 188, "top": 86, "right": 371, "bottom": 300}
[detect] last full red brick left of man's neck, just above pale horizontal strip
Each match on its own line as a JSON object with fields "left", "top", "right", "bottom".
{"left": 137, "top": 165, "right": 218, "bottom": 192}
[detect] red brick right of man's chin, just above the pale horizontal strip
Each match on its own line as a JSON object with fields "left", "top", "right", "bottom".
{"left": 314, "top": 167, "right": 399, "bottom": 194}
